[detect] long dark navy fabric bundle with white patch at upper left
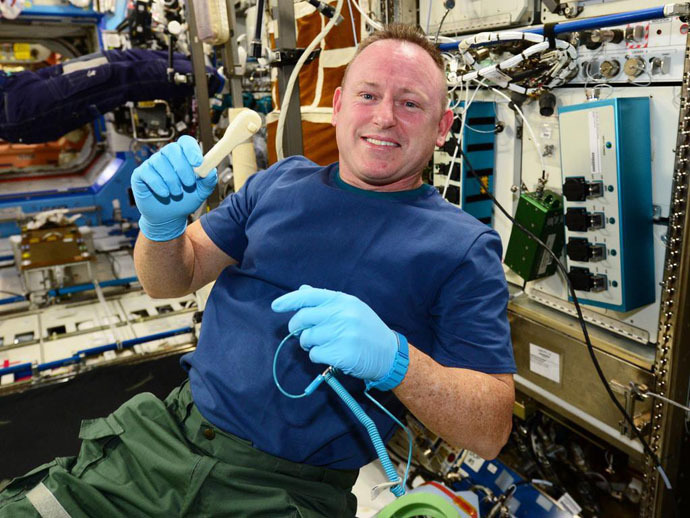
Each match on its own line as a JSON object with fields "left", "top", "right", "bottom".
{"left": 0, "top": 49, "right": 223, "bottom": 144}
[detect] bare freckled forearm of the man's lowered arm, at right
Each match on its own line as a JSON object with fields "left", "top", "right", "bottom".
{"left": 393, "top": 344, "right": 515, "bottom": 459}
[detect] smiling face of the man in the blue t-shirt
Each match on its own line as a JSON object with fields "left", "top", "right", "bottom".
{"left": 333, "top": 39, "right": 453, "bottom": 191}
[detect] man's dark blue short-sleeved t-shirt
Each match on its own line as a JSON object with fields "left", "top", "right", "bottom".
{"left": 183, "top": 157, "right": 515, "bottom": 469}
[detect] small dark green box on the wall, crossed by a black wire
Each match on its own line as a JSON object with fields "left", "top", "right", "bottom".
{"left": 503, "top": 191, "right": 563, "bottom": 281}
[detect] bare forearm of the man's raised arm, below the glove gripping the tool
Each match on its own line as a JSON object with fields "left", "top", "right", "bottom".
{"left": 134, "top": 232, "right": 194, "bottom": 298}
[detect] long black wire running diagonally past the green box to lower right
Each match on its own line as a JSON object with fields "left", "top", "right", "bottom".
{"left": 459, "top": 149, "right": 675, "bottom": 502}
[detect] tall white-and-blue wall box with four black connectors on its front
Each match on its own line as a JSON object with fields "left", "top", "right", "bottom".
{"left": 558, "top": 97, "right": 655, "bottom": 311}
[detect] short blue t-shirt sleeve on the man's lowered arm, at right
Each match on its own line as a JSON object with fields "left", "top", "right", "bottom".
{"left": 431, "top": 231, "right": 517, "bottom": 374}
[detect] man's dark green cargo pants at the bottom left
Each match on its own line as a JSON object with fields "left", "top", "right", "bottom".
{"left": 0, "top": 382, "right": 358, "bottom": 518}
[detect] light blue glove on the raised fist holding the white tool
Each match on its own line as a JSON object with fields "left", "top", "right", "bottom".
{"left": 132, "top": 135, "right": 218, "bottom": 245}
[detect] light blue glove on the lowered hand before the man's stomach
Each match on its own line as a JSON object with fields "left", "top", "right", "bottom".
{"left": 271, "top": 285, "right": 398, "bottom": 381}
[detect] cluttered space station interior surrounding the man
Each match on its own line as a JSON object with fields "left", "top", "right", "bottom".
{"left": 0, "top": 0, "right": 690, "bottom": 518}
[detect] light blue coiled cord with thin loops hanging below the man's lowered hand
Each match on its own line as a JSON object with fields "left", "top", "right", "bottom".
{"left": 273, "top": 328, "right": 412, "bottom": 497}
